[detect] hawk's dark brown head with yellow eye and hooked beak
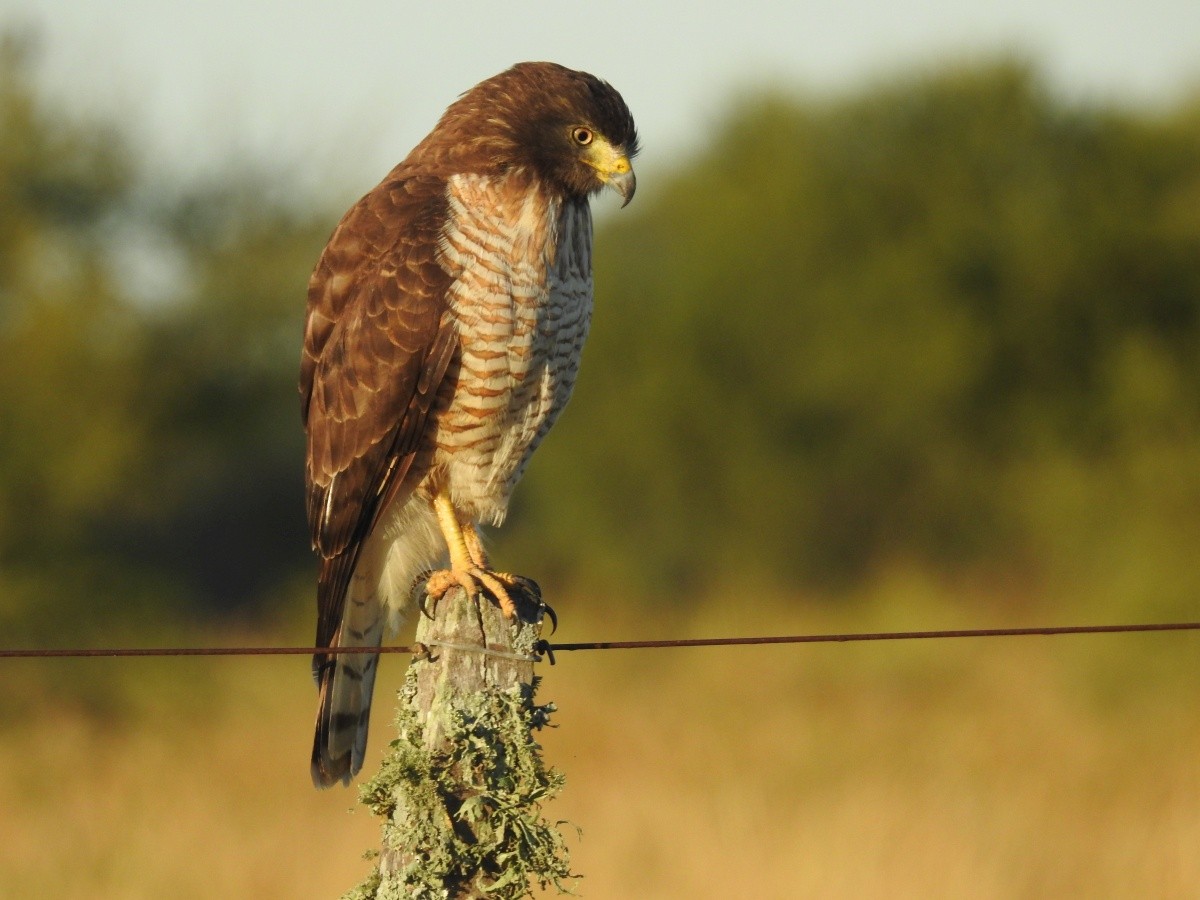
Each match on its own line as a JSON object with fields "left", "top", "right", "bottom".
{"left": 410, "top": 62, "right": 637, "bottom": 203}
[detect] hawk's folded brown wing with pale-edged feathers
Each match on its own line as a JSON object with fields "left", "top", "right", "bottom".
{"left": 300, "top": 174, "right": 457, "bottom": 666}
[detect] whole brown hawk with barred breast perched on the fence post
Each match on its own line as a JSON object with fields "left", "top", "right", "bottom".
{"left": 300, "top": 62, "right": 637, "bottom": 787}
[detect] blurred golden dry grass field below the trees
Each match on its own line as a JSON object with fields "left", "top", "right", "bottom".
{"left": 0, "top": 587, "right": 1200, "bottom": 899}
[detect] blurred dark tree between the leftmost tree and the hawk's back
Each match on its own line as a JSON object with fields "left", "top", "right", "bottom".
{"left": 100, "top": 172, "right": 334, "bottom": 624}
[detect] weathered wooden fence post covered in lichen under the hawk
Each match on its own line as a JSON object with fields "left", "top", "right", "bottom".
{"left": 343, "top": 587, "right": 571, "bottom": 900}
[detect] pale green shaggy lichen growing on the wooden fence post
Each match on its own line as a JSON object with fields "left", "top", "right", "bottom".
{"left": 343, "top": 670, "right": 575, "bottom": 900}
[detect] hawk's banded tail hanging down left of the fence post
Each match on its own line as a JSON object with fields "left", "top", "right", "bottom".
{"left": 312, "top": 604, "right": 384, "bottom": 787}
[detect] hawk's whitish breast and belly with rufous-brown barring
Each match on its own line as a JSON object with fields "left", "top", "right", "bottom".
{"left": 433, "top": 172, "right": 593, "bottom": 524}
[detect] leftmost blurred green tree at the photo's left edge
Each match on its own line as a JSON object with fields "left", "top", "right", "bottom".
{"left": 0, "top": 37, "right": 154, "bottom": 631}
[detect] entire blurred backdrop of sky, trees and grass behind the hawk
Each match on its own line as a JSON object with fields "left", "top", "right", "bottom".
{"left": 0, "top": 0, "right": 1200, "bottom": 898}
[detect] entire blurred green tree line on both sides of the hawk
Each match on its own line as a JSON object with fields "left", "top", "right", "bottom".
{"left": 0, "top": 41, "right": 1200, "bottom": 638}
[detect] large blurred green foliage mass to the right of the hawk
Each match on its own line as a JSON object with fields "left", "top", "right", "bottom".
{"left": 501, "top": 64, "right": 1200, "bottom": 614}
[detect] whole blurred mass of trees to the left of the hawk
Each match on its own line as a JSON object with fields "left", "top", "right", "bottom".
{"left": 0, "top": 37, "right": 330, "bottom": 640}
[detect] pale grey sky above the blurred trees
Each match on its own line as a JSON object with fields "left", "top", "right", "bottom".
{"left": 0, "top": 0, "right": 1200, "bottom": 196}
